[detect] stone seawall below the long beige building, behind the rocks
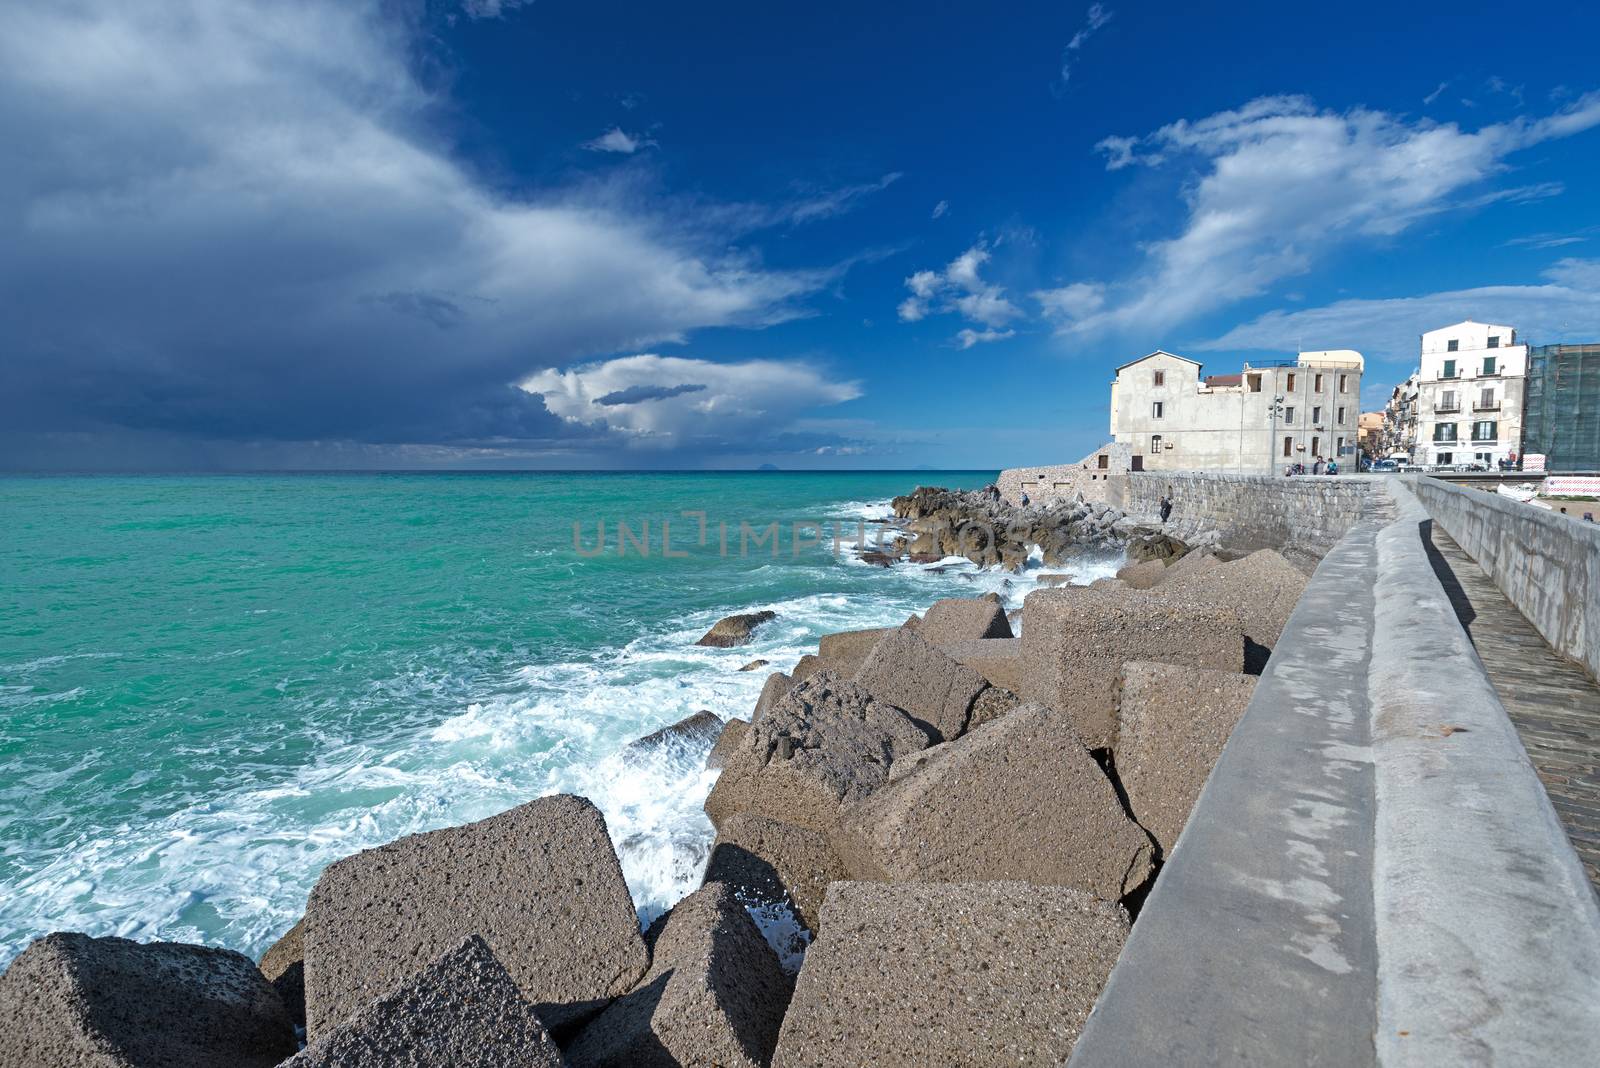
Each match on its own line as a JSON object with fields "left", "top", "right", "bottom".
{"left": 1110, "top": 472, "right": 1374, "bottom": 555}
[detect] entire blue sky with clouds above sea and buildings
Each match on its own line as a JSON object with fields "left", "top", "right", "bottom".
{"left": 0, "top": 0, "right": 1600, "bottom": 470}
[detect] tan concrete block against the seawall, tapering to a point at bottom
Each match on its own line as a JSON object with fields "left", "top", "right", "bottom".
{"left": 1117, "top": 662, "right": 1256, "bottom": 855}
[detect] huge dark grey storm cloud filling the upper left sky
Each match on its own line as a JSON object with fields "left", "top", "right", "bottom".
{"left": 0, "top": 0, "right": 864, "bottom": 464}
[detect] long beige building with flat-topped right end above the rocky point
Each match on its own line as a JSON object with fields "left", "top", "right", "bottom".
{"left": 1110, "top": 349, "right": 1363, "bottom": 473}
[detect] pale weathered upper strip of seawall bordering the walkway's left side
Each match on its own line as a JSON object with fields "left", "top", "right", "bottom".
{"left": 1370, "top": 486, "right": 1600, "bottom": 1065}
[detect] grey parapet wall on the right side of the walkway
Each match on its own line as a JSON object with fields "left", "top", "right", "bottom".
{"left": 1408, "top": 478, "right": 1600, "bottom": 678}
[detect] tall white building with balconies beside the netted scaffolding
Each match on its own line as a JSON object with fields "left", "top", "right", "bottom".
{"left": 1414, "top": 320, "right": 1528, "bottom": 467}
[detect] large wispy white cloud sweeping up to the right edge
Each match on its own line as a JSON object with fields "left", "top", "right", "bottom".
{"left": 1062, "top": 93, "right": 1600, "bottom": 333}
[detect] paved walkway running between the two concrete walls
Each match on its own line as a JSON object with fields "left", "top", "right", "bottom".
{"left": 1427, "top": 524, "right": 1600, "bottom": 894}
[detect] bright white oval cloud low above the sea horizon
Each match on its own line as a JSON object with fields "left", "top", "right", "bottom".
{"left": 522, "top": 353, "right": 861, "bottom": 449}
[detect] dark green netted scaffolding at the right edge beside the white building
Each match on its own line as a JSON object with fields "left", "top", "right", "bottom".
{"left": 1522, "top": 344, "right": 1600, "bottom": 472}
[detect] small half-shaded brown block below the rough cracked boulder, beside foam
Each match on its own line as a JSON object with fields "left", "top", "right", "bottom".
{"left": 704, "top": 812, "right": 851, "bottom": 932}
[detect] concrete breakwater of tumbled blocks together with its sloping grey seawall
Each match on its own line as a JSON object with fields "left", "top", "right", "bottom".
{"left": 9, "top": 484, "right": 1600, "bottom": 1068}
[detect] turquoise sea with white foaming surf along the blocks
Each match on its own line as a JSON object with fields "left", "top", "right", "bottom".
{"left": 0, "top": 472, "right": 1114, "bottom": 966}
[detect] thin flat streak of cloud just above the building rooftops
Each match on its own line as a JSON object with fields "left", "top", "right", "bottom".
{"left": 1192, "top": 259, "right": 1600, "bottom": 360}
